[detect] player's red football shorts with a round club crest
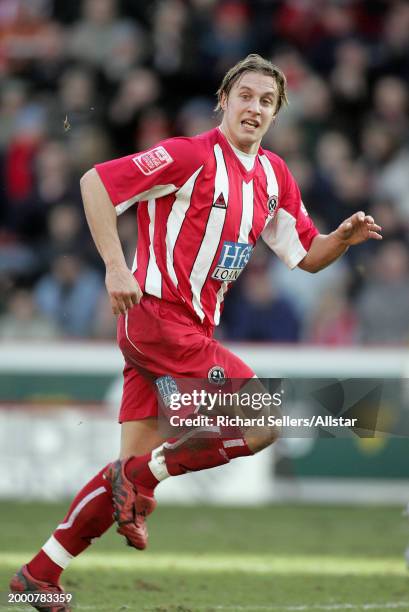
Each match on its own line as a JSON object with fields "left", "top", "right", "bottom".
{"left": 118, "top": 295, "right": 254, "bottom": 423}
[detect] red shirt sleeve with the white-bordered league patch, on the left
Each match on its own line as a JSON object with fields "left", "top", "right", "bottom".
{"left": 95, "top": 138, "right": 203, "bottom": 214}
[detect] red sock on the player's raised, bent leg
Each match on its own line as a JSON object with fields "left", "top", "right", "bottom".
{"left": 125, "top": 432, "right": 253, "bottom": 495}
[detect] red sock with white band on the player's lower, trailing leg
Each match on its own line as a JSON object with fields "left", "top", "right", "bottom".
{"left": 28, "top": 468, "right": 114, "bottom": 584}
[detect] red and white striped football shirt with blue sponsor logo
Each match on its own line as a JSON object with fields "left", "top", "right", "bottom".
{"left": 95, "top": 128, "right": 318, "bottom": 325}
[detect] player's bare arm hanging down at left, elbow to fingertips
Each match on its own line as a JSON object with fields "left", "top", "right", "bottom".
{"left": 80, "top": 168, "right": 142, "bottom": 314}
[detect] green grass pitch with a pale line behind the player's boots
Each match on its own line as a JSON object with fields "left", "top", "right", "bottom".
{"left": 0, "top": 502, "right": 409, "bottom": 612}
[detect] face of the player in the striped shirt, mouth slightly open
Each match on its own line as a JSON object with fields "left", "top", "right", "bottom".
{"left": 221, "top": 72, "right": 278, "bottom": 154}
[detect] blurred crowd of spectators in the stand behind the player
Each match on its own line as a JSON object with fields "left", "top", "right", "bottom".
{"left": 0, "top": 0, "right": 409, "bottom": 346}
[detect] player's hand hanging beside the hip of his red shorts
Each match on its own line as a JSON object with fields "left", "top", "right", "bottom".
{"left": 105, "top": 266, "right": 143, "bottom": 314}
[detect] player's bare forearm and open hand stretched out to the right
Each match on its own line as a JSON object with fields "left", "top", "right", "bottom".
{"left": 298, "top": 211, "right": 382, "bottom": 272}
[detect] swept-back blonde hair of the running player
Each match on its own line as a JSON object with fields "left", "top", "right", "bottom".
{"left": 215, "top": 53, "right": 288, "bottom": 115}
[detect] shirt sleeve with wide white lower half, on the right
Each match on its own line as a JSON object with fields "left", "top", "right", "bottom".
{"left": 262, "top": 160, "right": 319, "bottom": 268}
